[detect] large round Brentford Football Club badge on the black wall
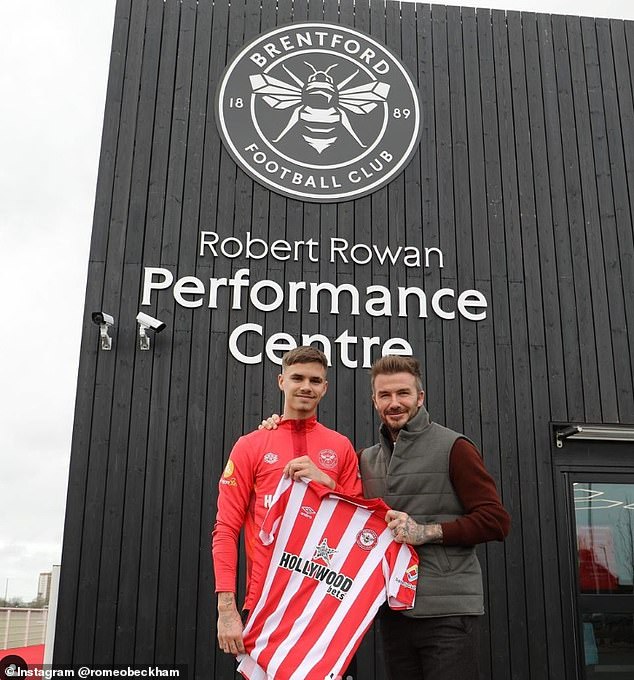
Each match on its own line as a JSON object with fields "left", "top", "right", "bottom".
{"left": 216, "top": 22, "right": 420, "bottom": 202}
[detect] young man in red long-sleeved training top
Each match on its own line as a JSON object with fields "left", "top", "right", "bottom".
{"left": 212, "top": 347, "right": 361, "bottom": 655}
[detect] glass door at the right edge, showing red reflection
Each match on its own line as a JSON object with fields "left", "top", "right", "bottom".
{"left": 569, "top": 473, "right": 634, "bottom": 680}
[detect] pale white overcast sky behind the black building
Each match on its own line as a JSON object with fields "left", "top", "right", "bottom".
{"left": 0, "top": 0, "right": 634, "bottom": 600}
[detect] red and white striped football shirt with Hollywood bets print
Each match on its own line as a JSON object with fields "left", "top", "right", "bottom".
{"left": 238, "top": 479, "right": 418, "bottom": 680}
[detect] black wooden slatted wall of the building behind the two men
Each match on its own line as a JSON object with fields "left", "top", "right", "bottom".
{"left": 55, "top": 0, "right": 634, "bottom": 680}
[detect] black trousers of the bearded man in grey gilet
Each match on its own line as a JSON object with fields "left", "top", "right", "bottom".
{"left": 379, "top": 609, "right": 480, "bottom": 680}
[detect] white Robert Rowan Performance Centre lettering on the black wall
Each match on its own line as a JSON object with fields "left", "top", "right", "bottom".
{"left": 141, "top": 231, "right": 488, "bottom": 369}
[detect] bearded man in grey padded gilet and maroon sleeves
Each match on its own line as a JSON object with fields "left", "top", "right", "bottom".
{"left": 360, "top": 356, "right": 510, "bottom": 680}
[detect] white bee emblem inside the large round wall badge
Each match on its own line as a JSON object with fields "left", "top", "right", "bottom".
{"left": 251, "top": 61, "right": 390, "bottom": 154}
